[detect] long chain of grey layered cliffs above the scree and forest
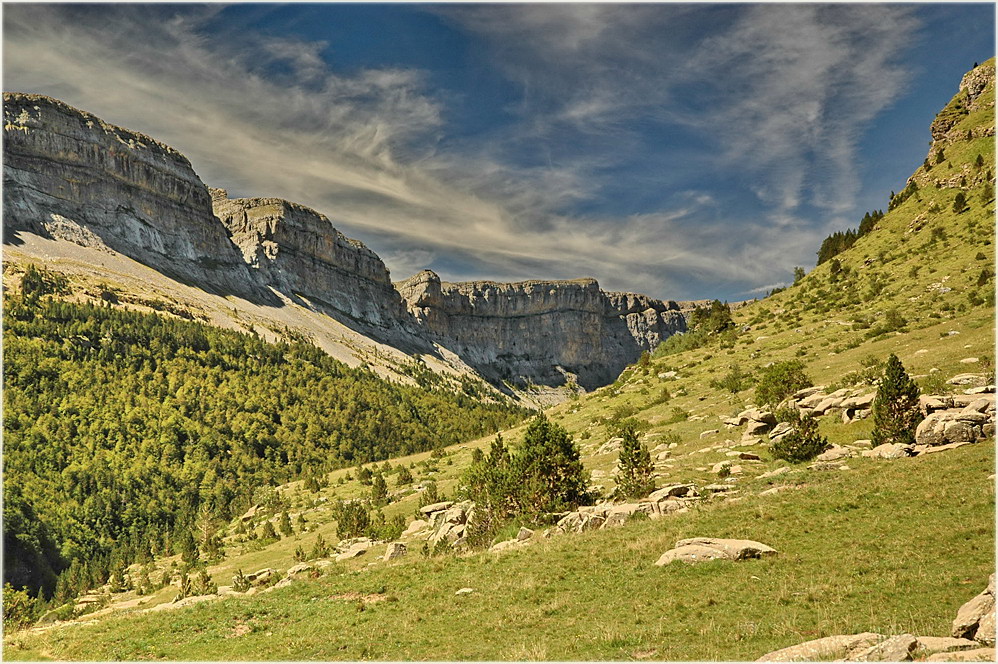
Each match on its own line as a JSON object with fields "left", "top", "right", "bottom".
{"left": 3, "top": 93, "right": 691, "bottom": 390}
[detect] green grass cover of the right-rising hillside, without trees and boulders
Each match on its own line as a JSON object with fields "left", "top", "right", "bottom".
{"left": 4, "top": 61, "right": 995, "bottom": 660}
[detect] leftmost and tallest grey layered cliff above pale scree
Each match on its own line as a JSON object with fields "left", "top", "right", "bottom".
{"left": 3, "top": 93, "right": 250, "bottom": 293}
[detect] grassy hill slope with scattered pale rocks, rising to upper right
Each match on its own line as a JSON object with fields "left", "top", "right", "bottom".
{"left": 4, "top": 61, "right": 995, "bottom": 661}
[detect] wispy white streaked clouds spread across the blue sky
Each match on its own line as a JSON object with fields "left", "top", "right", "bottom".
{"left": 4, "top": 4, "right": 911, "bottom": 298}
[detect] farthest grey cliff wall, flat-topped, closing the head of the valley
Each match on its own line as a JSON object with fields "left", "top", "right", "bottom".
{"left": 396, "top": 270, "right": 686, "bottom": 389}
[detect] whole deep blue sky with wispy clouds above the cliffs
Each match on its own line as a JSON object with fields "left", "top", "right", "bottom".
{"left": 3, "top": 2, "right": 995, "bottom": 301}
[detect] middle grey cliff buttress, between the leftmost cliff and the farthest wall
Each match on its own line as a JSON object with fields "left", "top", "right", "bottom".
{"left": 211, "top": 189, "right": 407, "bottom": 328}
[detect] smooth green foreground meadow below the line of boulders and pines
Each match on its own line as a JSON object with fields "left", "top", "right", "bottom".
{"left": 4, "top": 443, "right": 994, "bottom": 661}
